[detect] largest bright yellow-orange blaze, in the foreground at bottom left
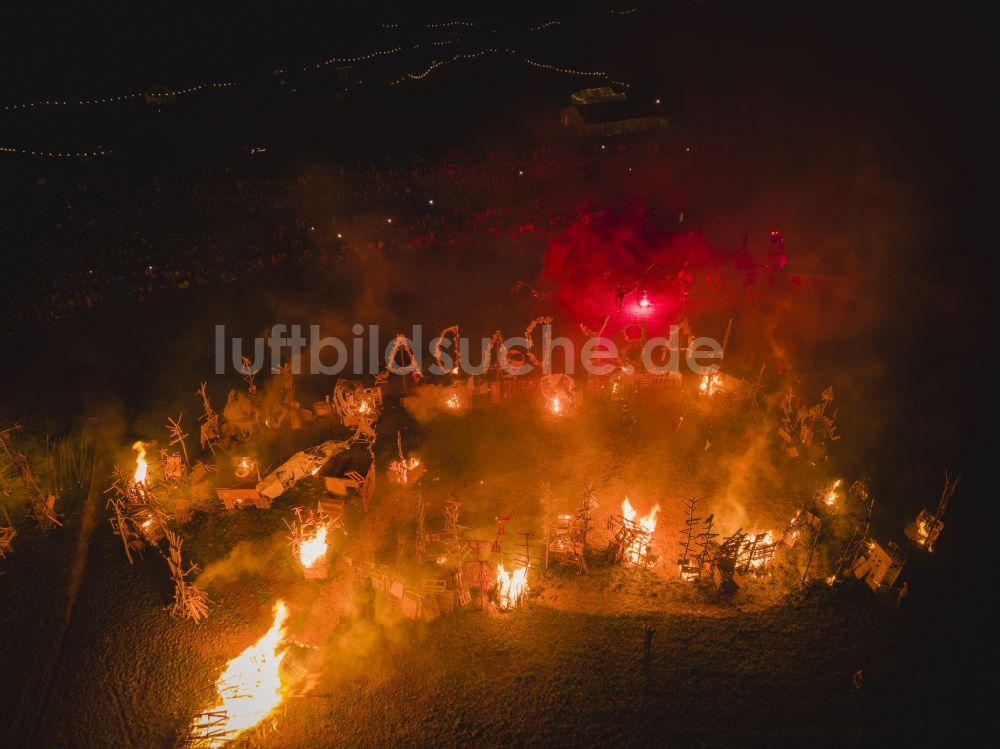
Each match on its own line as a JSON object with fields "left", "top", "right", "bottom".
{"left": 195, "top": 601, "right": 288, "bottom": 746}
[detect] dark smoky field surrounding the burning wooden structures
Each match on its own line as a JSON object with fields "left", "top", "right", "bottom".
{"left": 0, "top": 2, "right": 996, "bottom": 749}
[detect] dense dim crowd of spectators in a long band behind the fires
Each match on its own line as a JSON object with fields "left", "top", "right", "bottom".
{"left": 3, "top": 142, "right": 656, "bottom": 323}
